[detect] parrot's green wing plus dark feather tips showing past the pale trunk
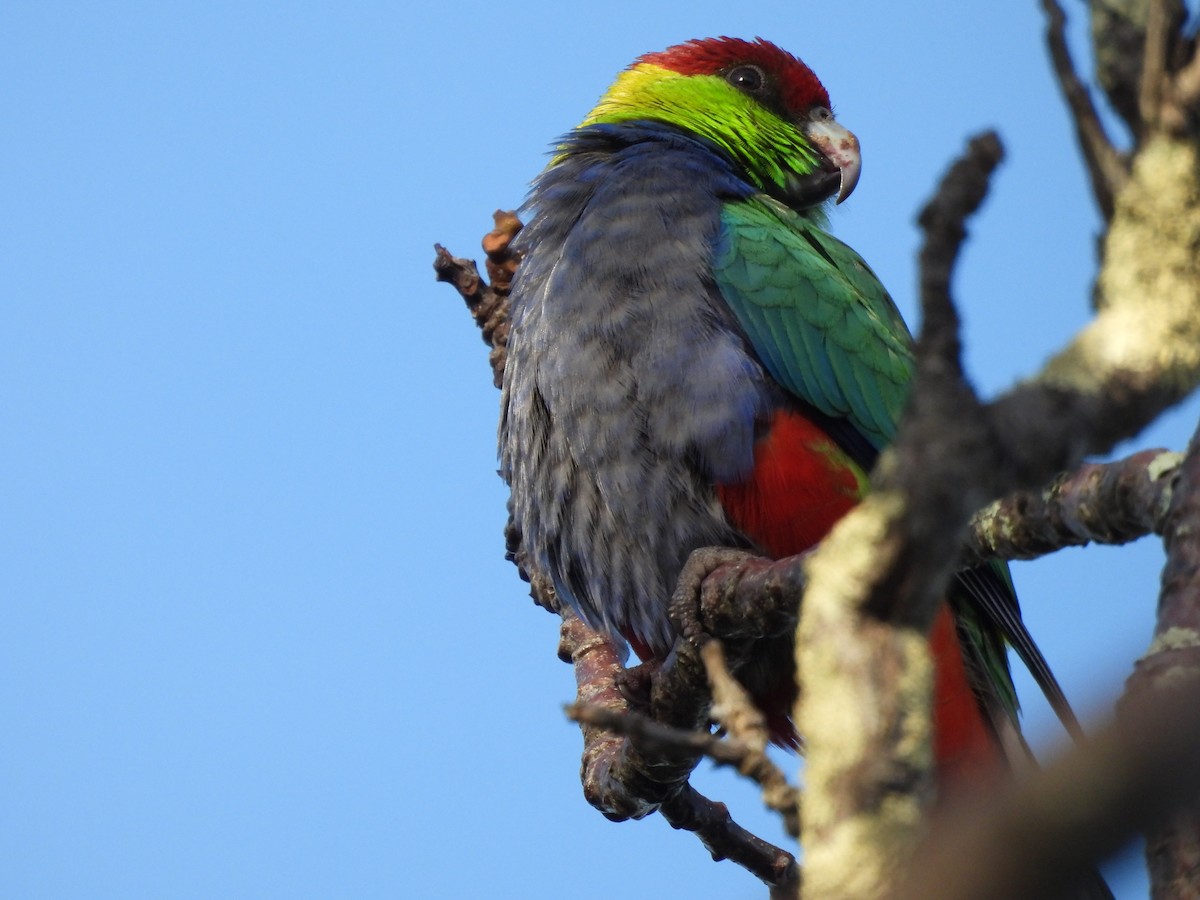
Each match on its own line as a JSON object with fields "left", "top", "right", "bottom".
{"left": 714, "top": 196, "right": 1078, "bottom": 728}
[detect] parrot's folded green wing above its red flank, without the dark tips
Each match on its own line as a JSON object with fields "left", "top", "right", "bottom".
{"left": 714, "top": 197, "right": 913, "bottom": 449}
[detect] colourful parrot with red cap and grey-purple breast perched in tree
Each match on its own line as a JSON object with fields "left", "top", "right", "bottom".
{"left": 498, "top": 37, "right": 1069, "bottom": 785}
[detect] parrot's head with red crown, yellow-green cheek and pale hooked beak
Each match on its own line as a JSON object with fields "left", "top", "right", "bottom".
{"left": 583, "top": 37, "right": 860, "bottom": 209}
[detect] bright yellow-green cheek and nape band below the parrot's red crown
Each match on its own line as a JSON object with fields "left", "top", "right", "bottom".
{"left": 571, "top": 62, "right": 817, "bottom": 201}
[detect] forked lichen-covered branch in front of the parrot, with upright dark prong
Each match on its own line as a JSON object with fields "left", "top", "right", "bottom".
{"left": 796, "top": 103, "right": 1200, "bottom": 898}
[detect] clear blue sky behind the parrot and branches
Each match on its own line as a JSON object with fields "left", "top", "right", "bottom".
{"left": 0, "top": 0, "right": 1198, "bottom": 898}
